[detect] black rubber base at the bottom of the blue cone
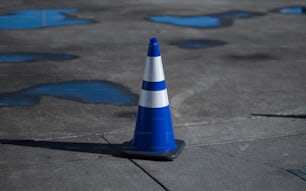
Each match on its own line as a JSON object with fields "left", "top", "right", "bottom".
{"left": 120, "top": 139, "right": 185, "bottom": 161}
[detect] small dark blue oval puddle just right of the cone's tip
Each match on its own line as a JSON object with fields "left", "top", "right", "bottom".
{"left": 172, "top": 40, "right": 226, "bottom": 49}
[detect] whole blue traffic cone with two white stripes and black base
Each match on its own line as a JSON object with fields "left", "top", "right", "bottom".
{"left": 122, "top": 38, "right": 185, "bottom": 160}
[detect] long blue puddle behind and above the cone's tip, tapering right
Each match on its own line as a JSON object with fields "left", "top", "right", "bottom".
{"left": 148, "top": 11, "right": 264, "bottom": 29}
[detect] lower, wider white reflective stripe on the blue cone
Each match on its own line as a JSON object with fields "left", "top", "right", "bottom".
{"left": 139, "top": 89, "right": 169, "bottom": 108}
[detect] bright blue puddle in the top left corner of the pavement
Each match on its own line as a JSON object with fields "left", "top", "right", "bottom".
{"left": 0, "top": 9, "right": 94, "bottom": 30}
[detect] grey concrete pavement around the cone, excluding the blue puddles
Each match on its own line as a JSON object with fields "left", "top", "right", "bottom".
{"left": 0, "top": 0, "right": 306, "bottom": 191}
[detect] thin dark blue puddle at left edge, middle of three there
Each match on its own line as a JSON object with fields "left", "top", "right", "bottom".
{"left": 0, "top": 52, "right": 78, "bottom": 63}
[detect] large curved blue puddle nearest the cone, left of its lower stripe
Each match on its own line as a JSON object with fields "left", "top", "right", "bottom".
{"left": 0, "top": 81, "right": 138, "bottom": 107}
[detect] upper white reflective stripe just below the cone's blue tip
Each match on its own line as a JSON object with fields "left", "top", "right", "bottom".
{"left": 143, "top": 56, "right": 165, "bottom": 82}
